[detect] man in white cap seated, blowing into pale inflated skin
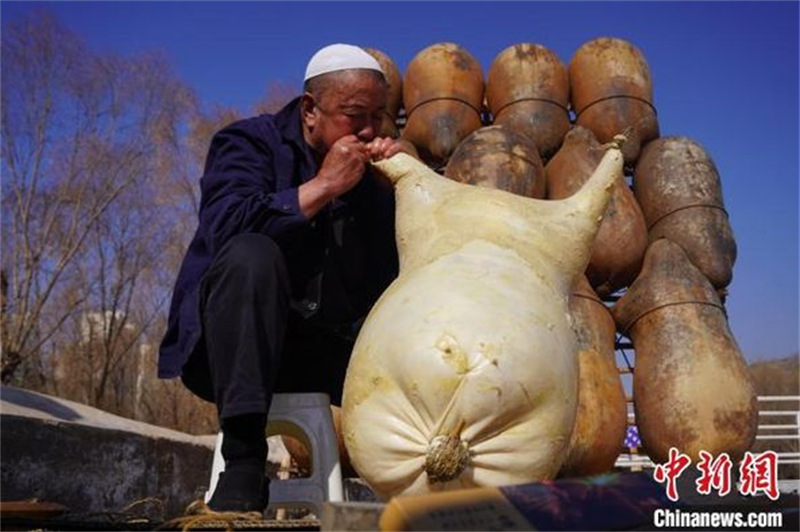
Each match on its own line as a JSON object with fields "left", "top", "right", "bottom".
{"left": 159, "top": 44, "right": 401, "bottom": 511}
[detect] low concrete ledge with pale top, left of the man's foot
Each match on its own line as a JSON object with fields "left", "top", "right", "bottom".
{"left": 0, "top": 386, "right": 214, "bottom": 518}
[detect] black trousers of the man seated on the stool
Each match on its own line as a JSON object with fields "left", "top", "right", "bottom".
{"left": 181, "top": 234, "right": 353, "bottom": 419}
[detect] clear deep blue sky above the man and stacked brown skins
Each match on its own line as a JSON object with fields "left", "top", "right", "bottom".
{"left": 1, "top": 0, "right": 800, "bottom": 360}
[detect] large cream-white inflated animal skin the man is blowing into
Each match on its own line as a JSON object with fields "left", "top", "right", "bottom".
{"left": 343, "top": 139, "right": 623, "bottom": 497}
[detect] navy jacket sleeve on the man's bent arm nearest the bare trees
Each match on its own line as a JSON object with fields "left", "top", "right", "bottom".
{"left": 200, "top": 120, "right": 308, "bottom": 256}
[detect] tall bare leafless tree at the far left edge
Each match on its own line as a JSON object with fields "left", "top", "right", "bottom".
{"left": 2, "top": 12, "right": 194, "bottom": 405}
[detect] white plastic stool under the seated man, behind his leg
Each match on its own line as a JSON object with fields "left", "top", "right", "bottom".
{"left": 205, "top": 393, "right": 344, "bottom": 516}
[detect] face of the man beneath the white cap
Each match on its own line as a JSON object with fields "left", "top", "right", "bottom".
{"left": 302, "top": 70, "right": 387, "bottom": 154}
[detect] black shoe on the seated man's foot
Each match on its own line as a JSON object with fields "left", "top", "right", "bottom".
{"left": 208, "top": 469, "right": 269, "bottom": 513}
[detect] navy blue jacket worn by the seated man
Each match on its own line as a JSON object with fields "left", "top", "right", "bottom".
{"left": 158, "top": 98, "right": 397, "bottom": 378}
